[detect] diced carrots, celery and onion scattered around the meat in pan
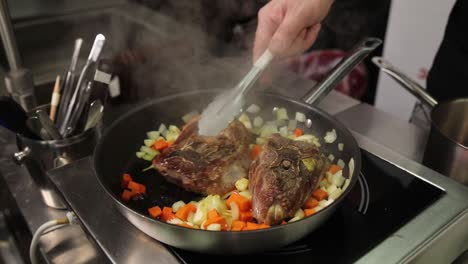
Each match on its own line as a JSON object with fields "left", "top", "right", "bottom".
{"left": 121, "top": 105, "right": 354, "bottom": 231}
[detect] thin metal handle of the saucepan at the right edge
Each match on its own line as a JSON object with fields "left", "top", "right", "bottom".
{"left": 372, "top": 57, "right": 437, "bottom": 108}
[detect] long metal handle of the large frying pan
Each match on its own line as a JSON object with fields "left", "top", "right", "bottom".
{"left": 302, "top": 38, "right": 382, "bottom": 105}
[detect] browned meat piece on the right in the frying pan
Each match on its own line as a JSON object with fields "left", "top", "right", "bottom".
{"left": 249, "top": 134, "right": 329, "bottom": 225}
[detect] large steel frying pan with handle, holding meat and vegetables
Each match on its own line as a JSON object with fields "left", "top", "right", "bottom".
{"left": 93, "top": 39, "right": 381, "bottom": 254}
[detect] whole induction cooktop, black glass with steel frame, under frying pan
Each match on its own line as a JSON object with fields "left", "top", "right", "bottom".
{"left": 44, "top": 135, "right": 468, "bottom": 264}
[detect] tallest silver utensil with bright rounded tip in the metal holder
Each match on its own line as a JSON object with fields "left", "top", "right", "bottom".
{"left": 60, "top": 34, "right": 106, "bottom": 137}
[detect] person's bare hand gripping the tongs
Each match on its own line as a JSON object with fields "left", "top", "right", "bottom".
{"left": 253, "top": 0, "right": 333, "bottom": 62}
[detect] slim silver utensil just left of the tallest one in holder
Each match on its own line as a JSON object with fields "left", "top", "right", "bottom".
{"left": 56, "top": 38, "right": 83, "bottom": 128}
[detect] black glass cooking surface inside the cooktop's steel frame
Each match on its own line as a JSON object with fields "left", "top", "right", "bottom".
{"left": 169, "top": 150, "right": 444, "bottom": 263}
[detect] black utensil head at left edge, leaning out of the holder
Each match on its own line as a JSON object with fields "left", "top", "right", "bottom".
{"left": 0, "top": 96, "right": 39, "bottom": 139}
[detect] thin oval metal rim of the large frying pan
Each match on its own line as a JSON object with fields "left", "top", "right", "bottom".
{"left": 92, "top": 89, "right": 362, "bottom": 235}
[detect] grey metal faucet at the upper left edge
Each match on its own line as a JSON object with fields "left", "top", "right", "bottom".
{"left": 0, "top": 0, "right": 37, "bottom": 111}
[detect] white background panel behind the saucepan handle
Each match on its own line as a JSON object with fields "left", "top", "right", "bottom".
{"left": 375, "top": 0, "right": 456, "bottom": 120}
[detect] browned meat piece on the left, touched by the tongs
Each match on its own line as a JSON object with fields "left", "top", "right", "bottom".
{"left": 153, "top": 120, "right": 251, "bottom": 195}
